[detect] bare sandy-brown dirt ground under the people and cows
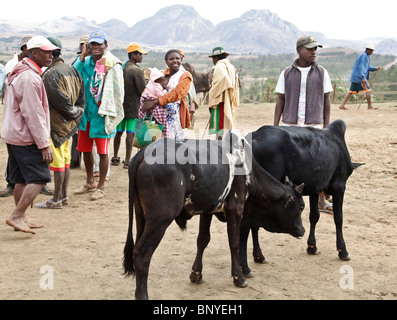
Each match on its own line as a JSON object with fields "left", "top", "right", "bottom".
{"left": 0, "top": 100, "right": 397, "bottom": 300}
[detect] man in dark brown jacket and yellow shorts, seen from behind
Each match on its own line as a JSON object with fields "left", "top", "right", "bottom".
{"left": 36, "top": 37, "right": 85, "bottom": 209}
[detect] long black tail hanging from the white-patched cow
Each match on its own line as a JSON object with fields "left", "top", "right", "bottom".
{"left": 123, "top": 152, "right": 143, "bottom": 277}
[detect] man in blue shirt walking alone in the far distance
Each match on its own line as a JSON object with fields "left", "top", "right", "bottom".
{"left": 339, "top": 44, "right": 380, "bottom": 110}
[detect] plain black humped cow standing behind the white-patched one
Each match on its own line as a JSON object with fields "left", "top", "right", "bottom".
{"left": 242, "top": 120, "right": 361, "bottom": 262}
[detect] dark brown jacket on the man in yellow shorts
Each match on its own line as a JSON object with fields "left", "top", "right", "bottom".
{"left": 43, "top": 58, "right": 85, "bottom": 148}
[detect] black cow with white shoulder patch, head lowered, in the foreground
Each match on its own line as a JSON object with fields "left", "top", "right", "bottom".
{"left": 124, "top": 134, "right": 304, "bottom": 299}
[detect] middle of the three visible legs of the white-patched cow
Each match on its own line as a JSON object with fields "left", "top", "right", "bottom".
{"left": 190, "top": 213, "right": 212, "bottom": 284}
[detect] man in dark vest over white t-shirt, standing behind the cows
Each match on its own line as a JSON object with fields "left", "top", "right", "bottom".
{"left": 274, "top": 37, "right": 332, "bottom": 213}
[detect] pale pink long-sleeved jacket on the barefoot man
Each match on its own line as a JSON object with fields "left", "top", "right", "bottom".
{"left": 1, "top": 58, "right": 51, "bottom": 149}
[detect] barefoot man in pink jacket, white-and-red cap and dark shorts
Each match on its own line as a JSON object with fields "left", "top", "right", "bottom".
{"left": 1, "top": 36, "right": 59, "bottom": 234}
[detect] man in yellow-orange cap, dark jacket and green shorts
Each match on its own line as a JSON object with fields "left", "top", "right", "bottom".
{"left": 111, "top": 43, "right": 147, "bottom": 169}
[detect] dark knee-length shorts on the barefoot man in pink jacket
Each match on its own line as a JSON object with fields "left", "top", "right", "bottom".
{"left": 7, "top": 144, "right": 51, "bottom": 184}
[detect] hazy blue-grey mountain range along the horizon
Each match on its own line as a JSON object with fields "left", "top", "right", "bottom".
{"left": 0, "top": 5, "right": 397, "bottom": 55}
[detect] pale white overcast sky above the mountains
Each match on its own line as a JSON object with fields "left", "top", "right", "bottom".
{"left": 0, "top": 0, "right": 397, "bottom": 40}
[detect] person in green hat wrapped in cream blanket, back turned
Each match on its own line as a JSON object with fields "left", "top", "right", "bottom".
{"left": 209, "top": 47, "right": 240, "bottom": 140}
